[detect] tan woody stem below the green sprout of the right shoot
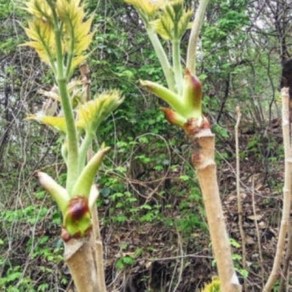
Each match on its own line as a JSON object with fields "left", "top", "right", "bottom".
{"left": 189, "top": 128, "right": 241, "bottom": 292}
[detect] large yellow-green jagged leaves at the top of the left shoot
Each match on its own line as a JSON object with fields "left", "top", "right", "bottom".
{"left": 24, "top": 0, "right": 93, "bottom": 74}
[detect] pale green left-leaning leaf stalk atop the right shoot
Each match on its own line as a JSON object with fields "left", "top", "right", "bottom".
{"left": 145, "top": 24, "right": 176, "bottom": 92}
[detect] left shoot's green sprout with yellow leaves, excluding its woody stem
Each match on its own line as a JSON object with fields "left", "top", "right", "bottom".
{"left": 24, "top": 0, "right": 123, "bottom": 240}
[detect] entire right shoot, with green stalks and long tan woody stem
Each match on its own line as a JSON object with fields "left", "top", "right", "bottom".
{"left": 125, "top": 0, "right": 241, "bottom": 292}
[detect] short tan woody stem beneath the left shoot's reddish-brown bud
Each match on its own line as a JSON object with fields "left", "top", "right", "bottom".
{"left": 65, "top": 232, "right": 106, "bottom": 292}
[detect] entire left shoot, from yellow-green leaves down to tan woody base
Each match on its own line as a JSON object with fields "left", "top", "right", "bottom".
{"left": 24, "top": 0, "right": 122, "bottom": 292}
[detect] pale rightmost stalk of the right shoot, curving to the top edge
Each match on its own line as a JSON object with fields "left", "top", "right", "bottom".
{"left": 186, "top": 0, "right": 209, "bottom": 75}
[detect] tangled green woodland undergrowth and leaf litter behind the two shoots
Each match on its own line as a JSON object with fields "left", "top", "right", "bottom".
{"left": 0, "top": 0, "right": 292, "bottom": 291}
